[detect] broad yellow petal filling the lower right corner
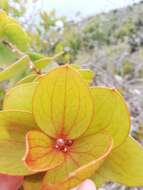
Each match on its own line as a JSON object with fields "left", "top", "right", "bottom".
{"left": 92, "top": 137, "right": 143, "bottom": 187}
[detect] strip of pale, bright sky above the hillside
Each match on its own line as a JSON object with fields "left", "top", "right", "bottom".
{"left": 37, "top": 0, "right": 141, "bottom": 18}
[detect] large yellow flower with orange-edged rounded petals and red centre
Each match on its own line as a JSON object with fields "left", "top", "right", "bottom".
{"left": 0, "top": 65, "right": 143, "bottom": 190}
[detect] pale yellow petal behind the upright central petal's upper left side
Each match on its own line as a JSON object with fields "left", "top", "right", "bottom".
{"left": 3, "top": 82, "right": 38, "bottom": 112}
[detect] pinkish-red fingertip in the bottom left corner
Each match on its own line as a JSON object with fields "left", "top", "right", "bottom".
{"left": 0, "top": 174, "right": 23, "bottom": 190}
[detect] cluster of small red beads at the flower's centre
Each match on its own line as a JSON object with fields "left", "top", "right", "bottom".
{"left": 55, "top": 138, "right": 73, "bottom": 153}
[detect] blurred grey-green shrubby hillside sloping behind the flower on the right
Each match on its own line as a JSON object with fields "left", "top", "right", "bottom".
{"left": 76, "top": 1, "right": 143, "bottom": 190}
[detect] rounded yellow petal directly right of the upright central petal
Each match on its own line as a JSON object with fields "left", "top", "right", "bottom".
{"left": 86, "top": 87, "right": 130, "bottom": 147}
